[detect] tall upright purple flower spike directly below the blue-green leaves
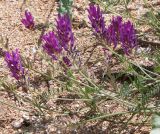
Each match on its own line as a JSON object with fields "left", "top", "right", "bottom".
{"left": 56, "top": 14, "right": 74, "bottom": 51}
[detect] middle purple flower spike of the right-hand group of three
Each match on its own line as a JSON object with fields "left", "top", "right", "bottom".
{"left": 106, "top": 16, "right": 122, "bottom": 48}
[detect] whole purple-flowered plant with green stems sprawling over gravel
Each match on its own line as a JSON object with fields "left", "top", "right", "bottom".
{"left": 2, "top": 3, "right": 160, "bottom": 133}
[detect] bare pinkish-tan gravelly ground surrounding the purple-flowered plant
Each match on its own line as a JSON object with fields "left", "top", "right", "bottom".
{"left": 0, "top": 0, "right": 160, "bottom": 134}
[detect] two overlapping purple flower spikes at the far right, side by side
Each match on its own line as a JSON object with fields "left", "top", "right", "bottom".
{"left": 106, "top": 16, "right": 137, "bottom": 55}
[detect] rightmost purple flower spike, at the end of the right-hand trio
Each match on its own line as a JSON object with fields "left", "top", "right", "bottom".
{"left": 120, "top": 21, "right": 137, "bottom": 55}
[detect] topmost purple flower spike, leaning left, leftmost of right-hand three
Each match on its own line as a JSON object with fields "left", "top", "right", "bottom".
{"left": 87, "top": 4, "right": 106, "bottom": 35}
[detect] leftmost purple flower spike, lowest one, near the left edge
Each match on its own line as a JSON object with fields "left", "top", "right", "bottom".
{"left": 5, "top": 49, "right": 25, "bottom": 80}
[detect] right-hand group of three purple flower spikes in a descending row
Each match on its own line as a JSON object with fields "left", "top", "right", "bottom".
{"left": 88, "top": 4, "right": 137, "bottom": 55}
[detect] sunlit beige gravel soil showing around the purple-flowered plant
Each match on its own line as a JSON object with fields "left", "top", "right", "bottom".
{"left": 0, "top": 0, "right": 158, "bottom": 134}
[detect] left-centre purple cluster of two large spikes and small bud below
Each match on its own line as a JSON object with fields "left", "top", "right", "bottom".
{"left": 42, "top": 14, "right": 74, "bottom": 67}
